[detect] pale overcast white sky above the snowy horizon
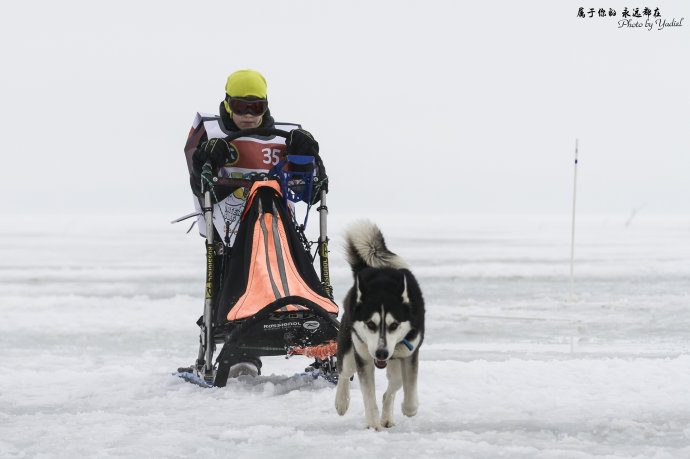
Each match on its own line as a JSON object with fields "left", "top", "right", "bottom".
{"left": 0, "top": 0, "right": 690, "bottom": 217}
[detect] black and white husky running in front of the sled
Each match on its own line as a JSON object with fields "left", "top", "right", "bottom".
{"left": 335, "top": 221, "right": 424, "bottom": 430}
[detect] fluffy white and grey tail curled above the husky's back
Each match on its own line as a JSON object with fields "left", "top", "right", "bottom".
{"left": 345, "top": 220, "right": 408, "bottom": 273}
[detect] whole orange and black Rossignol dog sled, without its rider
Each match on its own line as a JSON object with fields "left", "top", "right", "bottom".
{"left": 176, "top": 128, "right": 339, "bottom": 387}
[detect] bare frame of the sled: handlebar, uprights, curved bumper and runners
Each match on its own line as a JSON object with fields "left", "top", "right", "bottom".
{"left": 178, "top": 128, "right": 340, "bottom": 387}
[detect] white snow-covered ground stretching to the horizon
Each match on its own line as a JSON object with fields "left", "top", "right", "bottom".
{"left": 0, "top": 214, "right": 690, "bottom": 458}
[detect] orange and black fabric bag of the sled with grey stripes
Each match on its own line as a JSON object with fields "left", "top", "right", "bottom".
{"left": 214, "top": 180, "right": 339, "bottom": 386}
